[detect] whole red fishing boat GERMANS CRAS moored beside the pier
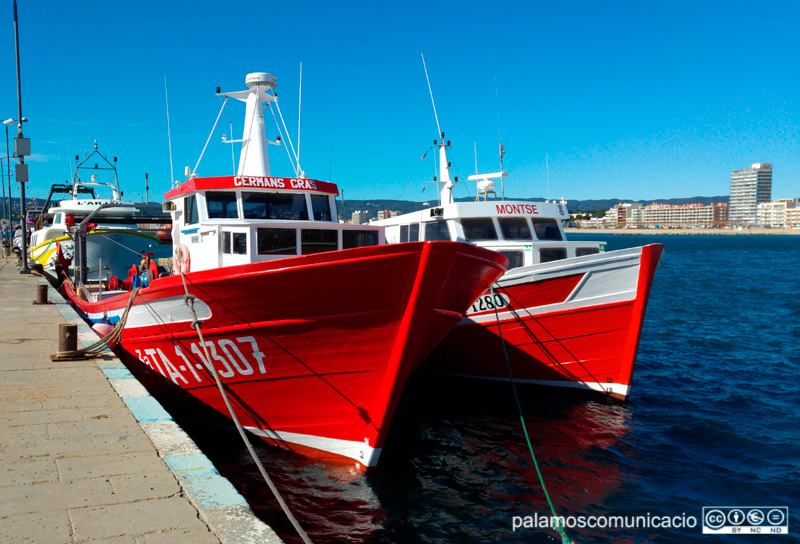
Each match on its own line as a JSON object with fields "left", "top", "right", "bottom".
{"left": 64, "top": 73, "right": 507, "bottom": 467}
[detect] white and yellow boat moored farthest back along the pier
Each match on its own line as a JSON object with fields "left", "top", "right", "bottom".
{"left": 29, "top": 142, "right": 172, "bottom": 282}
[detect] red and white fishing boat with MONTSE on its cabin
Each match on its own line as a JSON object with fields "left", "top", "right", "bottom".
{"left": 373, "top": 133, "right": 662, "bottom": 400}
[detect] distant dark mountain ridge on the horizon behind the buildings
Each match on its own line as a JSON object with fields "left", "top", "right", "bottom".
{"left": 338, "top": 196, "right": 728, "bottom": 218}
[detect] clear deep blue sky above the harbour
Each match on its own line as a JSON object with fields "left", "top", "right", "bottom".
{"left": 0, "top": 0, "right": 800, "bottom": 205}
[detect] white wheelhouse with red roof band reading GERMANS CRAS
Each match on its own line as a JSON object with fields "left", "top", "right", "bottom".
{"left": 165, "top": 176, "right": 385, "bottom": 271}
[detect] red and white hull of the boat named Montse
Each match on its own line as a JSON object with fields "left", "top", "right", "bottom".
{"left": 426, "top": 244, "right": 662, "bottom": 400}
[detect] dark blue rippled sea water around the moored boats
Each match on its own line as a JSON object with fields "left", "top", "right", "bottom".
{"left": 194, "top": 233, "right": 800, "bottom": 544}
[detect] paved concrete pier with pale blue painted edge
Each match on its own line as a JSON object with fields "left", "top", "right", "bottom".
{"left": 0, "top": 257, "right": 280, "bottom": 544}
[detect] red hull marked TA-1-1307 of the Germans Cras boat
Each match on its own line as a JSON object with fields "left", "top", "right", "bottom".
{"left": 66, "top": 242, "right": 506, "bottom": 467}
